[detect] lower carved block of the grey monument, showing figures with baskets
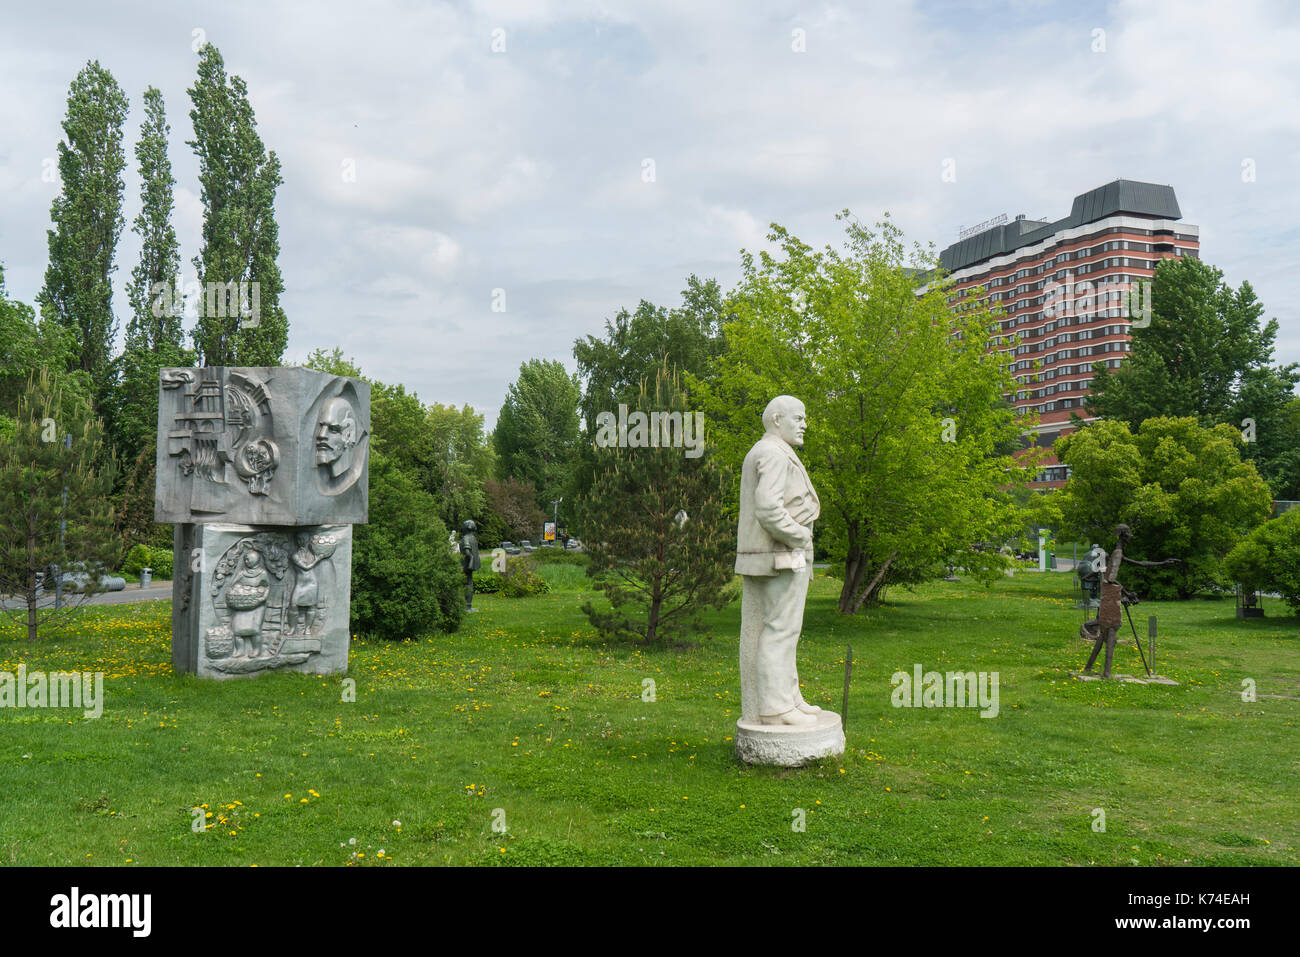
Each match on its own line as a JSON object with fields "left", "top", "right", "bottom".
{"left": 172, "top": 523, "right": 352, "bottom": 679}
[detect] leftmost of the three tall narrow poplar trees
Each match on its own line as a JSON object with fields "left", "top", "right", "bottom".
{"left": 39, "top": 60, "right": 127, "bottom": 407}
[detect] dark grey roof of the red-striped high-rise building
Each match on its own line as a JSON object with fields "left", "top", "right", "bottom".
{"left": 939, "top": 179, "right": 1183, "bottom": 272}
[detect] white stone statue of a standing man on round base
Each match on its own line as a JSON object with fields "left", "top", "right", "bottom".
{"left": 736, "top": 395, "right": 844, "bottom": 766}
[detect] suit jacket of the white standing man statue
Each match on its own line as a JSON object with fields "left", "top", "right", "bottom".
{"left": 736, "top": 434, "right": 822, "bottom": 576}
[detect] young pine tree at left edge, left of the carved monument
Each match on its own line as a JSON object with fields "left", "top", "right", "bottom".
{"left": 0, "top": 368, "right": 121, "bottom": 641}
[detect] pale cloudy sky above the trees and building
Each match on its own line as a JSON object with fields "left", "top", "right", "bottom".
{"left": 0, "top": 0, "right": 1300, "bottom": 425}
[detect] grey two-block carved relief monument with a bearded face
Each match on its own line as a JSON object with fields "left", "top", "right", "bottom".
{"left": 155, "top": 367, "right": 371, "bottom": 677}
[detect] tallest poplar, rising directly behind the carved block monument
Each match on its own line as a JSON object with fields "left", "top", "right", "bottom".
{"left": 189, "top": 43, "right": 289, "bottom": 365}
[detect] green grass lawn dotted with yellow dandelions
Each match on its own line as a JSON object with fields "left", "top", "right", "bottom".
{"left": 0, "top": 567, "right": 1300, "bottom": 866}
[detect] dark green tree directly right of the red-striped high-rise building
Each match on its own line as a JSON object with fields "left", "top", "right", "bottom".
{"left": 1089, "top": 257, "right": 1300, "bottom": 497}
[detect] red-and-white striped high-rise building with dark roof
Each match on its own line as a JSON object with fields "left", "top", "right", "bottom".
{"left": 939, "top": 179, "right": 1200, "bottom": 488}
